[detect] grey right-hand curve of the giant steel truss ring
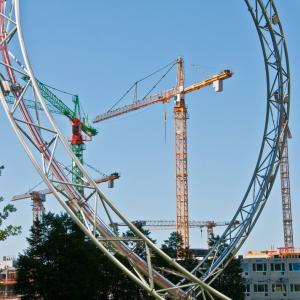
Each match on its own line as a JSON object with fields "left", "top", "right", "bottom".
{"left": 188, "top": 0, "right": 290, "bottom": 292}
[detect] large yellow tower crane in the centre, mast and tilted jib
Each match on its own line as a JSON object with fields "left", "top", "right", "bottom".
{"left": 93, "top": 57, "right": 233, "bottom": 257}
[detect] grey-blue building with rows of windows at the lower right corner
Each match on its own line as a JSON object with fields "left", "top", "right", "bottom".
{"left": 242, "top": 248, "right": 300, "bottom": 300}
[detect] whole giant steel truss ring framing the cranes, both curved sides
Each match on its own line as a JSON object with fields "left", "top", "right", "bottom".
{"left": 0, "top": 0, "right": 290, "bottom": 299}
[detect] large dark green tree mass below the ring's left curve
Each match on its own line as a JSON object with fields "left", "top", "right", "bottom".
{"left": 16, "top": 213, "right": 155, "bottom": 300}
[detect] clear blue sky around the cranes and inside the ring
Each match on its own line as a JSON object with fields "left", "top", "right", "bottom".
{"left": 0, "top": 0, "right": 300, "bottom": 255}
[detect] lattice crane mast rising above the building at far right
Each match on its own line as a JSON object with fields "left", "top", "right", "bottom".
{"left": 279, "top": 122, "right": 294, "bottom": 248}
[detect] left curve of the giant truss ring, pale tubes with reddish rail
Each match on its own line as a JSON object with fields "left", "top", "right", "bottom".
{"left": 0, "top": 0, "right": 230, "bottom": 299}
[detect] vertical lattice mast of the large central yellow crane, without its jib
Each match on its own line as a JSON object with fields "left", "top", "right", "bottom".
{"left": 173, "top": 57, "right": 189, "bottom": 257}
